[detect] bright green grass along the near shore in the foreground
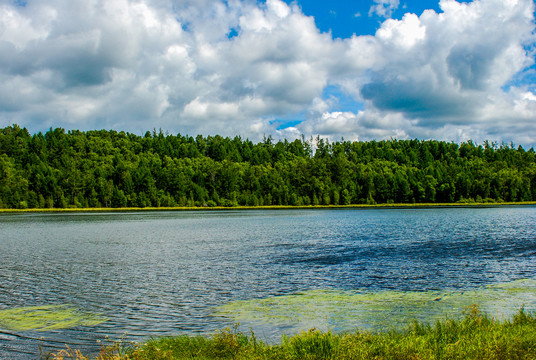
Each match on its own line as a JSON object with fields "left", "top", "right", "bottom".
{"left": 48, "top": 308, "right": 536, "bottom": 360}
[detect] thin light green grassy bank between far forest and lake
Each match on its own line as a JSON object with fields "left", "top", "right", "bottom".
{"left": 0, "top": 201, "right": 536, "bottom": 213}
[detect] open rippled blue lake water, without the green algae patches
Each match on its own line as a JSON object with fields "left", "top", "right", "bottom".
{"left": 0, "top": 206, "right": 536, "bottom": 359}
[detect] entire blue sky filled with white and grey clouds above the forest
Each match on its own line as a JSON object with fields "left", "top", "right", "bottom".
{"left": 0, "top": 0, "right": 536, "bottom": 147}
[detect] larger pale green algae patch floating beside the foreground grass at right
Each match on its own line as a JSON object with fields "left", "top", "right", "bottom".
{"left": 213, "top": 279, "right": 536, "bottom": 332}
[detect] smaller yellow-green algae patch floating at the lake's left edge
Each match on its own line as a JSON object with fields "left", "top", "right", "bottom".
{"left": 0, "top": 305, "right": 107, "bottom": 331}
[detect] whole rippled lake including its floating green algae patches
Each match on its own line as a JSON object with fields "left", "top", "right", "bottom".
{"left": 0, "top": 206, "right": 536, "bottom": 359}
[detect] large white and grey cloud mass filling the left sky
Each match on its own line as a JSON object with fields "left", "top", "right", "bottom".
{"left": 0, "top": 0, "right": 340, "bottom": 135}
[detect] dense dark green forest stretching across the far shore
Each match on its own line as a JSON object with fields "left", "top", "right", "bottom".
{"left": 0, "top": 125, "right": 536, "bottom": 208}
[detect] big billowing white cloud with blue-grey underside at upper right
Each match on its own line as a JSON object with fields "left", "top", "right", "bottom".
{"left": 361, "top": 0, "right": 533, "bottom": 123}
